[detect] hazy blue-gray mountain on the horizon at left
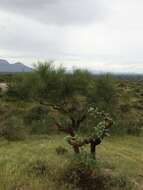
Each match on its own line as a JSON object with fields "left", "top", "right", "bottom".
{"left": 0, "top": 59, "right": 32, "bottom": 73}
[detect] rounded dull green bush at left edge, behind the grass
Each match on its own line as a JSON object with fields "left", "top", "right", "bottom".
{"left": 1, "top": 117, "right": 28, "bottom": 141}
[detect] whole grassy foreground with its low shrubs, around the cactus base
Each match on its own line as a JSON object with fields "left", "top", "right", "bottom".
{"left": 0, "top": 134, "right": 143, "bottom": 190}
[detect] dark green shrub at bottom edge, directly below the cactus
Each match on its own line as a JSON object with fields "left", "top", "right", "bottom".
{"left": 63, "top": 156, "right": 113, "bottom": 190}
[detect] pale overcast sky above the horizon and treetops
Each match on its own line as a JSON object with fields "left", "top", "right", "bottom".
{"left": 0, "top": 0, "right": 143, "bottom": 73}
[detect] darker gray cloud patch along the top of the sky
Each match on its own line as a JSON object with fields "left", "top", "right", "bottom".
{"left": 0, "top": 0, "right": 109, "bottom": 25}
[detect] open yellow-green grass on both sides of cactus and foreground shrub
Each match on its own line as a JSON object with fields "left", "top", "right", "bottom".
{"left": 0, "top": 135, "right": 143, "bottom": 190}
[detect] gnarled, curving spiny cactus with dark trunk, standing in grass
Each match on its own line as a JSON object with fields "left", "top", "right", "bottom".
{"left": 66, "top": 108, "right": 113, "bottom": 158}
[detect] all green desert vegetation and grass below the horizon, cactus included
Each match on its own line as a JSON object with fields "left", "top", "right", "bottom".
{"left": 0, "top": 63, "right": 143, "bottom": 190}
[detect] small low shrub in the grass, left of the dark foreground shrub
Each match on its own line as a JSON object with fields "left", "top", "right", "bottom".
{"left": 26, "top": 160, "right": 50, "bottom": 177}
